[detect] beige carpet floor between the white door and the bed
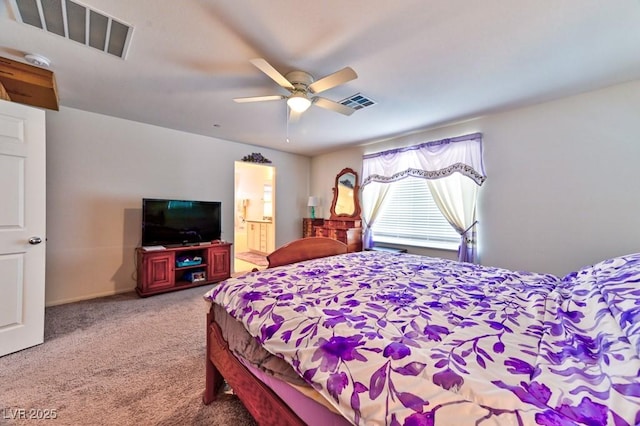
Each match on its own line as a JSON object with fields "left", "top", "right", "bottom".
{"left": 0, "top": 286, "right": 256, "bottom": 426}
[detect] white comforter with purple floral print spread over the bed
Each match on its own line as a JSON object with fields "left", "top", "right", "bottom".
{"left": 205, "top": 252, "right": 640, "bottom": 425}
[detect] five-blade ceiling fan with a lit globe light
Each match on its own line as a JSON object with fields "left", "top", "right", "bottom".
{"left": 233, "top": 58, "right": 358, "bottom": 120}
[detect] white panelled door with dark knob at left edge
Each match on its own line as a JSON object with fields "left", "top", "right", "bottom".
{"left": 0, "top": 101, "right": 46, "bottom": 356}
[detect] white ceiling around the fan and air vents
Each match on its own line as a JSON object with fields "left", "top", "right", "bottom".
{"left": 0, "top": 0, "right": 640, "bottom": 155}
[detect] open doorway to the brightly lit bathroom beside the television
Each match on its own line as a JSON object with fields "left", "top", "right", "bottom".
{"left": 233, "top": 161, "right": 276, "bottom": 273}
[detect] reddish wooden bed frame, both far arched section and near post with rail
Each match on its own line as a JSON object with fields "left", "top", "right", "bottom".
{"left": 202, "top": 237, "right": 347, "bottom": 426}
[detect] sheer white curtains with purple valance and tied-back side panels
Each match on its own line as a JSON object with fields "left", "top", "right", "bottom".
{"left": 362, "top": 133, "right": 486, "bottom": 262}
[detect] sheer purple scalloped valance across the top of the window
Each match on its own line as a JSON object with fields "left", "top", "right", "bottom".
{"left": 362, "top": 133, "right": 486, "bottom": 186}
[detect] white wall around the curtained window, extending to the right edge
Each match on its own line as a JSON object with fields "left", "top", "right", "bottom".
{"left": 311, "top": 81, "right": 640, "bottom": 276}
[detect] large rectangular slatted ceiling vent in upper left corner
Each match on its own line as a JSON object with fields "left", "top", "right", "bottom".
{"left": 9, "top": 0, "right": 133, "bottom": 59}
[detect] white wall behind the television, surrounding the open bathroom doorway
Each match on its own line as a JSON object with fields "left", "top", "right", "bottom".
{"left": 46, "top": 108, "right": 310, "bottom": 305}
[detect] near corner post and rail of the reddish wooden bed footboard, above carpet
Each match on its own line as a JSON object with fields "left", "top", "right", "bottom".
{"left": 202, "top": 309, "right": 305, "bottom": 426}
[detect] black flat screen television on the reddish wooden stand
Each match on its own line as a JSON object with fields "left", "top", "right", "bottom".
{"left": 142, "top": 198, "right": 222, "bottom": 246}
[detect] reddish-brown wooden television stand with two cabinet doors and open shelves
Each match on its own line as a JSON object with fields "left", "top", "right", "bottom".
{"left": 136, "top": 241, "right": 231, "bottom": 297}
